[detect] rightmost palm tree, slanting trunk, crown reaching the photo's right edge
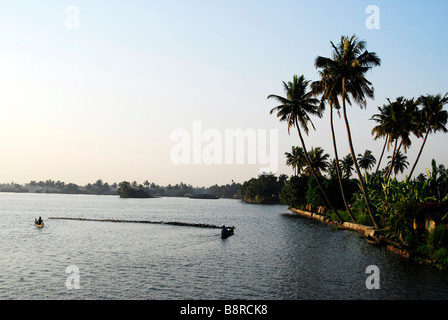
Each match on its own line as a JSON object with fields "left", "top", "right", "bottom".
{"left": 409, "top": 93, "right": 448, "bottom": 179}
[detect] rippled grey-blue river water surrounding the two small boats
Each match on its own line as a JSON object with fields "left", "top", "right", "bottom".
{"left": 0, "top": 193, "right": 448, "bottom": 300}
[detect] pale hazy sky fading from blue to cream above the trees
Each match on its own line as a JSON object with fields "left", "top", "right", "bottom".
{"left": 0, "top": 0, "right": 448, "bottom": 186}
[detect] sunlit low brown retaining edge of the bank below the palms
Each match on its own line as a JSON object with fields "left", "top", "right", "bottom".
{"left": 289, "top": 208, "right": 412, "bottom": 259}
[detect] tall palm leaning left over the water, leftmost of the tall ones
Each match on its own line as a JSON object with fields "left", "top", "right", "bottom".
{"left": 268, "top": 75, "right": 344, "bottom": 221}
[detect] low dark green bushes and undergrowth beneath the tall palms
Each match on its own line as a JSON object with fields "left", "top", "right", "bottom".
{"left": 245, "top": 157, "right": 448, "bottom": 269}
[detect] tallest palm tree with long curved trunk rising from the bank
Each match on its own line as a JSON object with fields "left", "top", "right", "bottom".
{"left": 315, "top": 36, "right": 381, "bottom": 228}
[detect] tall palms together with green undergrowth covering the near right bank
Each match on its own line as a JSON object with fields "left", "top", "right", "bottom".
{"left": 260, "top": 36, "right": 448, "bottom": 267}
